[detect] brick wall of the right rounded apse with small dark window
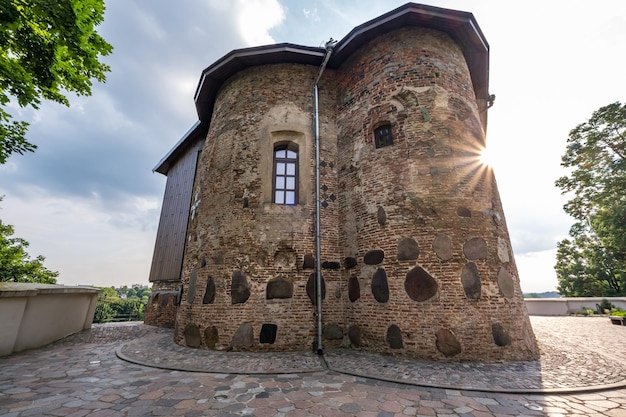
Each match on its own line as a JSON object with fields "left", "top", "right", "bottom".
{"left": 337, "top": 28, "right": 537, "bottom": 360}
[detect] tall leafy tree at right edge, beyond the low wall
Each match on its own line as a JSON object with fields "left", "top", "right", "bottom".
{"left": 555, "top": 102, "right": 626, "bottom": 296}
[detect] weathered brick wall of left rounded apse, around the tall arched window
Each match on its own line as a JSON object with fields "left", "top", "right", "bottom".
{"left": 175, "top": 64, "right": 340, "bottom": 350}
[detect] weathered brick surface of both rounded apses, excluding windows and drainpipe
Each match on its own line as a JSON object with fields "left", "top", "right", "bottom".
{"left": 169, "top": 28, "right": 537, "bottom": 360}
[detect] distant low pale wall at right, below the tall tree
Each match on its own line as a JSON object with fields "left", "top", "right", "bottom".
{"left": 524, "top": 297, "right": 626, "bottom": 316}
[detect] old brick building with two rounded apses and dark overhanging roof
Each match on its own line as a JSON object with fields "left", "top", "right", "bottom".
{"left": 146, "top": 3, "right": 538, "bottom": 361}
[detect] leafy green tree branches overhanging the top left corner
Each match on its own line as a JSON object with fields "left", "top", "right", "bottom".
{"left": 0, "top": 0, "right": 113, "bottom": 164}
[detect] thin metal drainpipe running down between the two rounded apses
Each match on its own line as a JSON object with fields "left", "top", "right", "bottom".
{"left": 313, "top": 38, "right": 336, "bottom": 355}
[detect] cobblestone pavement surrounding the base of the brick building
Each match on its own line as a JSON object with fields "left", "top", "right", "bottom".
{"left": 0, "top": 317, "right": 626, "bottom": 417}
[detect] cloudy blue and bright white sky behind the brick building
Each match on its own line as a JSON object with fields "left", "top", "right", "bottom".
{"left": 0, "top": 0, "right": 626, "bottom": 292}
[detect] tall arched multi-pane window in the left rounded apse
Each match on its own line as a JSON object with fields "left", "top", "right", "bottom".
{"left": 273, "top": 143, "right": 298, "bottom": 206}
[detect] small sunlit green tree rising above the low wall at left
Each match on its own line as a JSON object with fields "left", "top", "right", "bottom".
{"left": 0, "top": 214, "right": 59, "bottom": 284}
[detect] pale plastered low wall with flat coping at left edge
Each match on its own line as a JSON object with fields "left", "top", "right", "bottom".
{"left": 0, "top": 282, "right": 100, "bottom": 356}
